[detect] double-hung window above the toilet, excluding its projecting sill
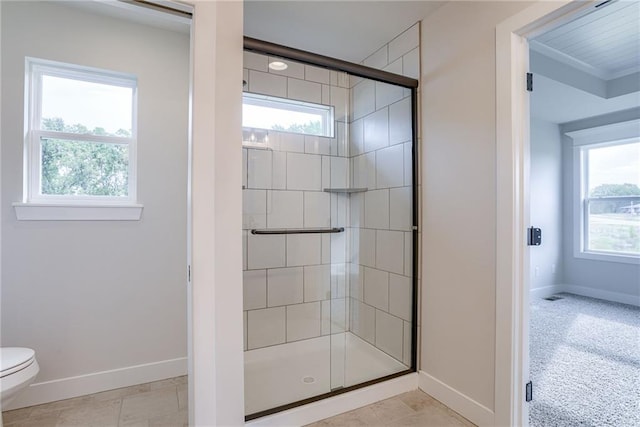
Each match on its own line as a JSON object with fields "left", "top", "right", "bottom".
{"left": 24, "top": 58, "right": 137, "bottom": 205}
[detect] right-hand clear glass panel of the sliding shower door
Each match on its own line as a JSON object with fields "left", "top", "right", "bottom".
{"left": 331, "top": 78, "right": 413, "bottom": 388}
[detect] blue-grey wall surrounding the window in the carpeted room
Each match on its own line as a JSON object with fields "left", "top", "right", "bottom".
{"left": 560, "top": 108, "right": 640, "bottom": 304}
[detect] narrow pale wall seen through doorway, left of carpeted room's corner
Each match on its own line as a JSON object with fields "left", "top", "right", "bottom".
{"left": 529, "top": 117, "right": 563, "bottom": 289}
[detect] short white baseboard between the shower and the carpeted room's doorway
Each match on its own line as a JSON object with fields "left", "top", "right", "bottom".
{"left": 418, "top": 371, "right": 495, "bottom": 427}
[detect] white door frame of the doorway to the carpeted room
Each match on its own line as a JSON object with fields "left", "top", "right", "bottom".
{"left": 494, "top": 0, "right": 601, "bottom": 426}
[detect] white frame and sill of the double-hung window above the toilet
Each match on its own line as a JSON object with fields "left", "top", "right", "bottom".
{"left": 14, "top": 57, "right": 142, "bottom": 220}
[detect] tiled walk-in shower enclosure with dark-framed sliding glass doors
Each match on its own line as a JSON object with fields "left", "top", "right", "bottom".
{"left": 242, "top": 39, "right": 417, "bottom": 419}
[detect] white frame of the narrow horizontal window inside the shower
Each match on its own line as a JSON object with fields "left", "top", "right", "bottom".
{"left": 242, "top": 92, "right": 335, "bottom": 138}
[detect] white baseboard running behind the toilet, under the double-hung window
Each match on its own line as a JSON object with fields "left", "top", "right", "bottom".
{"left": 2, "top": 356, "right": 187, "bottom": 411}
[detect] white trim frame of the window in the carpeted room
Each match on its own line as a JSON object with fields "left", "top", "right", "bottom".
{"left": 565, "top": 120, "right": 640, "bottom": 264}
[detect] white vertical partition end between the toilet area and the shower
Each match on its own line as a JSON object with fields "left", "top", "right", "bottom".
{"left": 188, "top": 0, "right": 244, "bottom": 426}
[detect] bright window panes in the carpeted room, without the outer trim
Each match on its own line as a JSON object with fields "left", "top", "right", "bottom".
{"left": 579, "top": 139, "right": 640, "bottom": 257}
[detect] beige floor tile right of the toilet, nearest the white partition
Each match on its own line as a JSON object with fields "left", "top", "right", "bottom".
{"left": 120, "top": 386, "right": 178, "bottom": 423}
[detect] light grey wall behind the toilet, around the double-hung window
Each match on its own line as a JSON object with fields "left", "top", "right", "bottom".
{"left": 2, "top": 2, "right": 189, "bottom": 404}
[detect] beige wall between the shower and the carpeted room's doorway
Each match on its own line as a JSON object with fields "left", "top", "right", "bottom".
{"left": 420, "top": 2, "right": 529, "bottom": 422}
